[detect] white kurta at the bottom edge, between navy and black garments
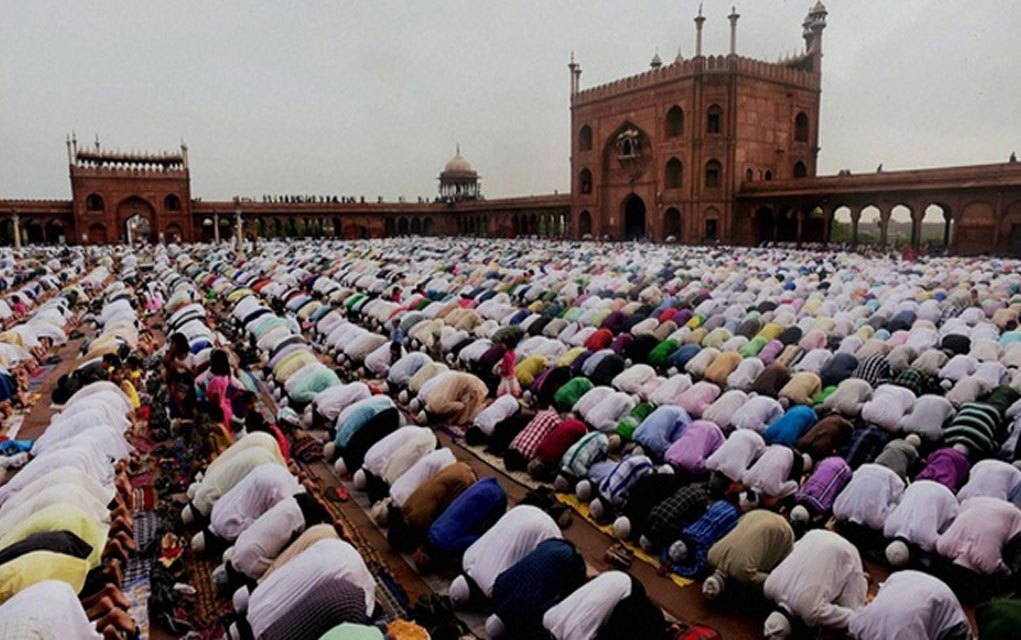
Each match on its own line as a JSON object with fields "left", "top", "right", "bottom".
{"left": 542, "top": 571, "right": 631, "bottom": 640}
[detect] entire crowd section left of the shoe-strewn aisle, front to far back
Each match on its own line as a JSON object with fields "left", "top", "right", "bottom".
{"left": 0, "top": 252, "right": 155, "bottom": 639}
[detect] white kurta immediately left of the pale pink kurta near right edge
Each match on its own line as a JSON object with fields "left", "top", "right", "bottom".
{"left": 883, "top": 480, "right": 958, "bottom": 551}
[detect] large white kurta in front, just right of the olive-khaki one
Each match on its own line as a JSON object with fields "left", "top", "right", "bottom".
{"left": 763, "top": 529, "right": 869, "bottom": 629}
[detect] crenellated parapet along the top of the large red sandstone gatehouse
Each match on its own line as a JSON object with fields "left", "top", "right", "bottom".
{"left": 572, "top": 54, "right": 820, "bottom": 106}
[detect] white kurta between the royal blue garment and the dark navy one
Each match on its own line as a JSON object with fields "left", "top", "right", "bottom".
{"left": 461, "top": 505, "right": 563, "bottom": 598}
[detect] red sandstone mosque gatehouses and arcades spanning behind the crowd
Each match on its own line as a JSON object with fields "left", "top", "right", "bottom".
{"left": 0, "top": 2, "right": 1021, "bottom": 256}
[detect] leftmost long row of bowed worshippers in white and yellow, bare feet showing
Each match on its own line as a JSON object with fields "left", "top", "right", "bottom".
{"left": 0, "top": 273, "right": 148, "bottom": 638}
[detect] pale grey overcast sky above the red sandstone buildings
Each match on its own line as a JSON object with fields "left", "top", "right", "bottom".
{"left": 0, "top": 0, "right": 1021, "bottom": 200}
